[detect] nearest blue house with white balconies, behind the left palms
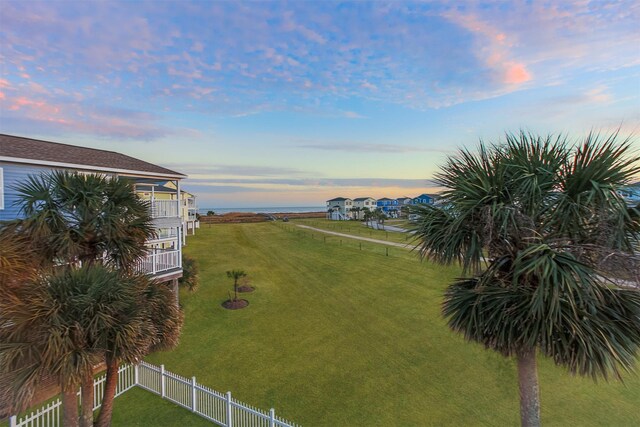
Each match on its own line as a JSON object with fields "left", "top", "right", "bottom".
{"left": 0, "top": 134, "right": 186, "bottom": 292}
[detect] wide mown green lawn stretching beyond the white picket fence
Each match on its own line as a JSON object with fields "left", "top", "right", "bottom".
{"left": 114, "top": 223, "right": 640, "bottom": 426}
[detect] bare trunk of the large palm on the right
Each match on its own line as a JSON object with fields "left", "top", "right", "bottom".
{"left": 517, "top": 348, "right": 540, "bottom": 427}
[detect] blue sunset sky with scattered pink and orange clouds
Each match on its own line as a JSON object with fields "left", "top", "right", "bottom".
{"left": 0, "top": 0, "right": 640, "bottom": 208}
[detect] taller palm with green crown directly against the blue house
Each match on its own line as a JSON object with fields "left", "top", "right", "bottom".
{"left": 3, "top": 171, "right": 162, "bottom": 425}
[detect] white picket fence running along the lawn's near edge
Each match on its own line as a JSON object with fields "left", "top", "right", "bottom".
{"left": 9, "top": 362, "right": 300, "bottom": 427}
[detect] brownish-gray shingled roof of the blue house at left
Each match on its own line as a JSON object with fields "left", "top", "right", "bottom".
{"left": 0, "top": 134, "right": 186, "bottom": 178}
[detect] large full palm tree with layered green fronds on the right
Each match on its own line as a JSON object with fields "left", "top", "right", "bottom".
{"left": 415, "top": 132, "right": 640, "bottom": 426}
